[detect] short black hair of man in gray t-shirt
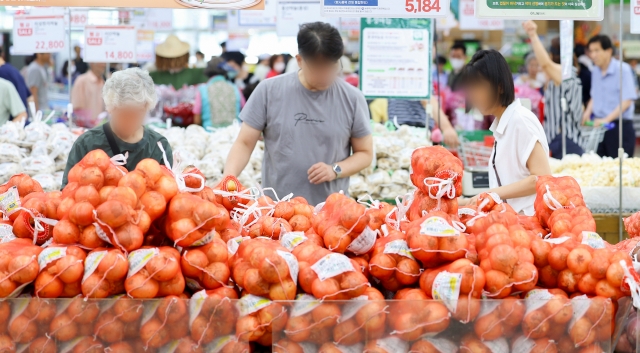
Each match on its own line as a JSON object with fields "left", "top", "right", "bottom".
{"left": 298, "top": 22, "right": 344, "bottom": 61}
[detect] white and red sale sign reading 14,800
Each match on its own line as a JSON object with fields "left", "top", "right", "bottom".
{"left": 84, "top": 26, "right": 137, "bottom": 63}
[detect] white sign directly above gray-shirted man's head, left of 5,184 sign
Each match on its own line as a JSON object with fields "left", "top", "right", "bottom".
{"left": 276, "top": 0, "right": 340, "bottom": 37}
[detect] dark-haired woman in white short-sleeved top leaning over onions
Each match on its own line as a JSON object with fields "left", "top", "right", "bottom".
{"left": 462, "top": 50, "right": 551, "bottom": 216}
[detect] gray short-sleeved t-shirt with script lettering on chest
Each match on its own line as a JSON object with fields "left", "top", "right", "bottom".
{"left": 240, "top": 72, "right": 371, "bottom": 205}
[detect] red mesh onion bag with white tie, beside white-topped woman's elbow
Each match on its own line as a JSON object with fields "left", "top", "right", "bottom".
{"left": 533, "top": 175, "right": 586, "bottom": 227}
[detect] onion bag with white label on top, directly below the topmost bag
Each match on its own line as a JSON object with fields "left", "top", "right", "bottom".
{"left": 407, "top": 211, "right": 474, "bottom": 268}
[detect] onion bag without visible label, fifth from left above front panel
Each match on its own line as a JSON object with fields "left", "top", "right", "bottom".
{"left": 180, "top": 238, "right": 233, "bottom": 289}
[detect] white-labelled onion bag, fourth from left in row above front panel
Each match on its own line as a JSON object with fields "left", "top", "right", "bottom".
{"left": 124, "top": 246, "right": 185, "bottom": 298}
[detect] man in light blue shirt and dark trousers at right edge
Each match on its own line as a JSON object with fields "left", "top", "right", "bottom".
{"left": 582, "top": 35, "right": 638, "bottom": 158}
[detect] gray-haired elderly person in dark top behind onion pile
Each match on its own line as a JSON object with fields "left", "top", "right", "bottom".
{"left": 62, "top": 68, "right": 173, "bottom": 188}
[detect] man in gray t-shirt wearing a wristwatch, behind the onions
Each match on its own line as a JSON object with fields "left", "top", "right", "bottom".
{"left": 224, "top": 22, "right": 373, "bottom": 205}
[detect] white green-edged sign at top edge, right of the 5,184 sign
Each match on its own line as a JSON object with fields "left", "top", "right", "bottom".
{"left": 476, "top": 0, "right": 604, "bottom": 21}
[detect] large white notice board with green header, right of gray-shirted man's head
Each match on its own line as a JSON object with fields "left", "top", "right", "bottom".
{"left": 360, "top": 18, "right": 432, "bottom": 99}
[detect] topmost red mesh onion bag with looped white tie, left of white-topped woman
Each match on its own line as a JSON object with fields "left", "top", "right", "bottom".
{"left": 411, "top": 146, "right": 464, "bottom": 199}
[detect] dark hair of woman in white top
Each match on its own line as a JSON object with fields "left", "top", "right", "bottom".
{"left": 461, "top": 49, "right": 515, "bottom": 107}
